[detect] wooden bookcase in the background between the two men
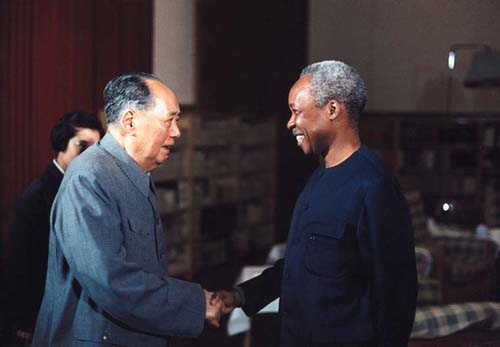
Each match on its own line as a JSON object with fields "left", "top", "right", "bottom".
{"left": 152, "top": 111, "right": 276, "bottom": 277}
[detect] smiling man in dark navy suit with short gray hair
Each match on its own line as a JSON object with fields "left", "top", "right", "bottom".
{"left": 218, "top": 61, "right": 417, "bottom": 347}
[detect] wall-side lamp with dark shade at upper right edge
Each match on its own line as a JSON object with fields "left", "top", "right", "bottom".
{"left": 446, "top": 43, "right": 500, "bottom": 113}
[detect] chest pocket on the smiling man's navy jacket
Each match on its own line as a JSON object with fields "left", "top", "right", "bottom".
{"left": 305, "top": 221, "right": 359, "bottom": 279}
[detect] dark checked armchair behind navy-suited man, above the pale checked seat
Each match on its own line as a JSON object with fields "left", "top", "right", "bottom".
{"left": 405, "top": 191, "right": 497, "bottom": 305}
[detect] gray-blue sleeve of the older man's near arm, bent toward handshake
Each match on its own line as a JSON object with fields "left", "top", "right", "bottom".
{"left": 52, "top": 175, "right": 206, "bottom": 336}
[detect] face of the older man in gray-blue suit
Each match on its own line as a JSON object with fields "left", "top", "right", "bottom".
{"left": 129, "top": 81, "right": 181, "bottom": 171}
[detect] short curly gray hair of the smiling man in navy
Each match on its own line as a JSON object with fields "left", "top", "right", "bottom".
{"left": 300, "top": 60, "right": 367, "bottom": 124}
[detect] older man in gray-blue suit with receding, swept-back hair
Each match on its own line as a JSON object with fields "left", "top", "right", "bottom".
{"left": 33, "top": 73, "right": 222, "bottom": 347}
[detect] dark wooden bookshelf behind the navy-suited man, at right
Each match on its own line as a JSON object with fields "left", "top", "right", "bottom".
{"left": 360, "top": 113, "right": 500, "bottom": 226}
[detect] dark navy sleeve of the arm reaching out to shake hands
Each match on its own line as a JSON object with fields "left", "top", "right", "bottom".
{"left": 238, "top": 259, "right": 284, "bottom": 316}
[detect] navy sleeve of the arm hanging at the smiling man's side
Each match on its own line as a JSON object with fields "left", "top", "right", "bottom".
{"left": 361, "top": 180, "right": 417, "bottom": 346}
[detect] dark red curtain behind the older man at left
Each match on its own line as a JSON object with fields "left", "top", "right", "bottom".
{"left": 0, "top": 0, "right": 153, "bottom": 266}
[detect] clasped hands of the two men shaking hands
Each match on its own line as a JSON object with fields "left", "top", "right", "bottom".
{"left": 205, "top": 289, "right": 241, "bottom": 328}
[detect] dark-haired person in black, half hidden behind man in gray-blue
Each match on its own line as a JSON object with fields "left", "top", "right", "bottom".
{"left": 6, "top": 112, "right": 104, "bottom": 343}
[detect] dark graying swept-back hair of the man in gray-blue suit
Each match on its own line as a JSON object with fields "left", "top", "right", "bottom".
{"left": 103, "top": 72, "right": 161, "bottom": 124}
